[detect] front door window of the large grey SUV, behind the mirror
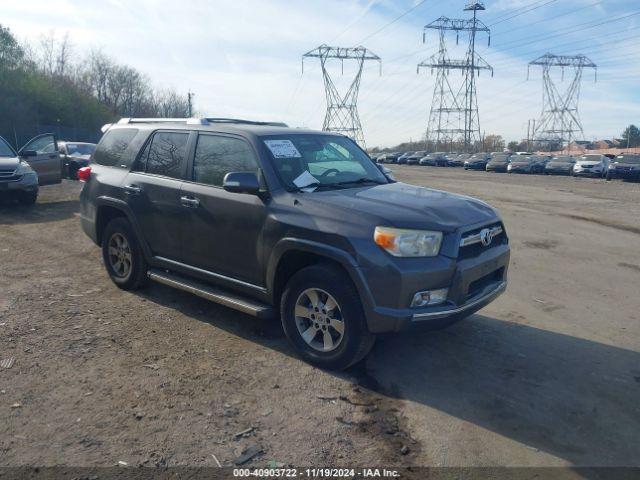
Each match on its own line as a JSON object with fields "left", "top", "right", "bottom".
{"left": 193, "top": 135, "right": 258, "bottom": 187}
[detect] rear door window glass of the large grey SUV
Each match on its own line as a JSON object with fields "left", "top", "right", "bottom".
{"left": 136, "top": 132, "right": 189, "bottom": 178}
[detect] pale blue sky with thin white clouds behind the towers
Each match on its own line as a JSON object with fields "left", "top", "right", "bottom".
{"left": 0, "top": 0, "right": 640, "bottom": 147}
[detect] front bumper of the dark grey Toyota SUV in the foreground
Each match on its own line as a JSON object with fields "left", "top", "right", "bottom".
{"left": 365, "top": 244, "right": 511, "bottom": 333}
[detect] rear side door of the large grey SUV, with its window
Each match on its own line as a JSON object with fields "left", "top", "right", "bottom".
{"left": 122, "top": 130, "right": 195, "bottom": 261}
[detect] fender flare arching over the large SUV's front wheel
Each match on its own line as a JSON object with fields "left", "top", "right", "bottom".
{"left": 266, "top": 237, "right": 374, "bottom": 312}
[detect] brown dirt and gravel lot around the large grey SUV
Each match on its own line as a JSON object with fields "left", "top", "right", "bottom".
{"left": 0, "top": 167, "right": 640, "bottom": 466}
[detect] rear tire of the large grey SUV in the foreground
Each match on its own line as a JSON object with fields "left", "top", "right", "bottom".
{"left": 102, "top": 217, "right": 149, "bottom": 290}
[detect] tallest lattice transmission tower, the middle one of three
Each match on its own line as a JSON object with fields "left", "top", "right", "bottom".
{"left": 418, "top": 1, "right": 493, "bottom": 151}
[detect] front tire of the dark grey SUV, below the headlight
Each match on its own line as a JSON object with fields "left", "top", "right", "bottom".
{"left": 280, "top": 264, "right": 375, "bottom": 370}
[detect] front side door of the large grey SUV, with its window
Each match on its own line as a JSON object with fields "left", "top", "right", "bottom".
{"left": 180, "top": 133, "right": 267, "bottom": 286}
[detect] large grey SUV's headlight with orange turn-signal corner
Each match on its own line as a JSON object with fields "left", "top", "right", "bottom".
{"left": 373, "top": 227, "right": 442, "bottom": 257}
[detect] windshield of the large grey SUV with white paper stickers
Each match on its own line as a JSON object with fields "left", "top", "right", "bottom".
{"left": 262, "top": 134, "right": 389, "bottom": 190}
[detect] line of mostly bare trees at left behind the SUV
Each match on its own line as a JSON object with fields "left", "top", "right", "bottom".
{"left": 0, "top": 25, "right": 189, "bottom": 146}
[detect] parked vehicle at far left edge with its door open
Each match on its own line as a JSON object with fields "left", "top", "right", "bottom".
{"left": 0, "top": 134, "right": 62, "bottom": 205}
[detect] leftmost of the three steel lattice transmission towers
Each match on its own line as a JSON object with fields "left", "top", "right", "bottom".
{"left": 302, "top": 45, "right": 382, "bottom": 148}
